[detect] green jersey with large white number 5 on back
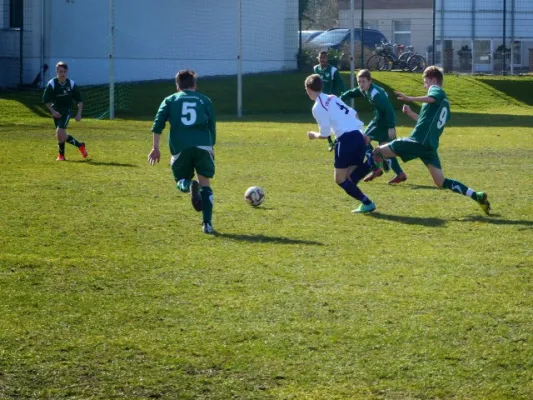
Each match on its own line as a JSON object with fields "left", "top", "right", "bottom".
{"left": 152, "top": 90, "right": 216, "bottom": 155}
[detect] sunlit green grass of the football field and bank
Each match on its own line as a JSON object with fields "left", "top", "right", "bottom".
{"left": 0, "top": 74, "right": 533, "bottom": 400}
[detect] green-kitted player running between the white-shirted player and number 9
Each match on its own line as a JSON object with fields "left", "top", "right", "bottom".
{"left": 341, "top": 69, "right": 407, "bottom": 184}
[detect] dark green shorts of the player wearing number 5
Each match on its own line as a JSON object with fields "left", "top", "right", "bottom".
{"left": 170, "top": 147, "right": 215, "bottom": 182}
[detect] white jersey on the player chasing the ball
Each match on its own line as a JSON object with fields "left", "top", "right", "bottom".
{"left": 313, "top": 93, "right": 364, "bottom": 138}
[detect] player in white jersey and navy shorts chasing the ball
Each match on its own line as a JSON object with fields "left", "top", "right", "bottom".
{"left": 305, "top": 74, "right": 376, "bottom": 213}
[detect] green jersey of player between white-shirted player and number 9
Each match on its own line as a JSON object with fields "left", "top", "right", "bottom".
{"left": 341, "top": 83, "right": 396, "bottom": 129}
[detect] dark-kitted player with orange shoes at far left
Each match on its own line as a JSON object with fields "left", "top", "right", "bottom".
{"left": 43, "top": 61, "right": 87, "bottom": 161}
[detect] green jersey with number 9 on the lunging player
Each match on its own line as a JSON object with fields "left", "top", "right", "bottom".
{"left": 410, "top": 85, "right": 450, "bottom": 149}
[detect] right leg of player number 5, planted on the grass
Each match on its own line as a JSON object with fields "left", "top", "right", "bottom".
{"left": 191, "top": 148, "right": 215, "bottom": 234}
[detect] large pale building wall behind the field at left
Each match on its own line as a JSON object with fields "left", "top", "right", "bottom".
{"left": 0, "top": 0, "right": 298, "bottom": 87}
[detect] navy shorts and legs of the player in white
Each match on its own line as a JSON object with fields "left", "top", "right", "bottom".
{"left": 334, "top": 132, "right": 376, "bottom": 212}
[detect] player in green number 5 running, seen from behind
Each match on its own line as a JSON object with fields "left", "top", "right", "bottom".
{"left": 148, "top": 70, "right": 216, "bottom": 234}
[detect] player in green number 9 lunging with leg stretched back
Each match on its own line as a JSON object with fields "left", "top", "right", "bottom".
{"left": 374, "top": 66, "right": 490, "bottom": 215}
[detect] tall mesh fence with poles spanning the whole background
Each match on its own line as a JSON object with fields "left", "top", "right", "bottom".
{"left": 0, "top": 0, "right": 533, "bottom": 117}
